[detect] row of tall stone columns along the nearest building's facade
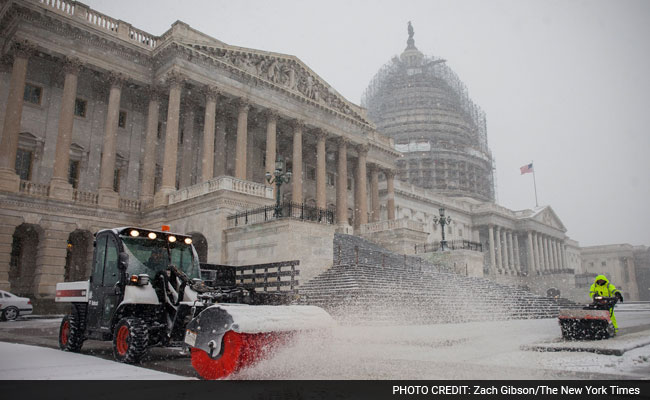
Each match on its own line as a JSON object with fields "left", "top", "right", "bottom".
{"left": 0, "top": 43, "right": 395, "bottom": 226}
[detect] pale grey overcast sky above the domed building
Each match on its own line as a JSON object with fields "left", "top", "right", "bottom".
{"left": 84, "top": 0, "right": 650, "bottom": 246}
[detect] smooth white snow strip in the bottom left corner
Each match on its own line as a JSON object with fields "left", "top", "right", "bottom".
{"left": 0, "top": 342, "right": 188, "bottom": 380}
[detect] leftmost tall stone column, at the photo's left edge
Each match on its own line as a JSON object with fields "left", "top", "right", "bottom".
{"left": 0, "top": 42, "right": 33, "bottom": 193}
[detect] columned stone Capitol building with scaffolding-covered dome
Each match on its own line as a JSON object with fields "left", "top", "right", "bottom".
{"left": 0, "top": 0, "right": 650, "bottom": 312}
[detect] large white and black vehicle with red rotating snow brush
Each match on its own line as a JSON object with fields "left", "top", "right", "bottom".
{"left": 56, "top": 227, "right": 334, "bottom": 379}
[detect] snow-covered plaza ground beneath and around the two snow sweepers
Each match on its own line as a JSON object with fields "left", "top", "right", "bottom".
{"left": 0, "top": 304, "right": 650, "bottom": 380}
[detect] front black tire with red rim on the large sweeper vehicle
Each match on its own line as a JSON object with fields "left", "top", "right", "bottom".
{"left": 113, "top": 317, "right": 149, "bottom": 364}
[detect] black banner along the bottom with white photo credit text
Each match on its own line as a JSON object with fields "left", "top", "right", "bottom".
{"left": 0, "top": 381, "right": 650, "bottom": 400}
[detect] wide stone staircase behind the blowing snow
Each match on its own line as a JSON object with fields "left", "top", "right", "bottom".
{"left": 300, "top": 234, "right": 559, "bottom": 324}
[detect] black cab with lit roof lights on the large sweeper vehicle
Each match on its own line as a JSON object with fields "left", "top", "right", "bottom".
{"left": 87, "top": 227, "right": 200, "bottom": 340}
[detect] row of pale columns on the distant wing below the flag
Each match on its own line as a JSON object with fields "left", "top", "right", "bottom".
{"left": 488, "top": 225, "right": 567, "bottom": 275}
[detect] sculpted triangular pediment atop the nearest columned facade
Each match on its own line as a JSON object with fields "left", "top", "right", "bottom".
{"left": 184, "top": 41, "right": 370, "bottom": 125}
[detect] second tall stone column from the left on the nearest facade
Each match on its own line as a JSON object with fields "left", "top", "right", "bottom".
{"left": 50, "top": 59, "right": 81, "bottom": 200}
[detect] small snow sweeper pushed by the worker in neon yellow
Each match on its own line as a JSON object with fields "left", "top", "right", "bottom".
{"left": 558, "top": 296, "right": 618, "bottom": 340}
